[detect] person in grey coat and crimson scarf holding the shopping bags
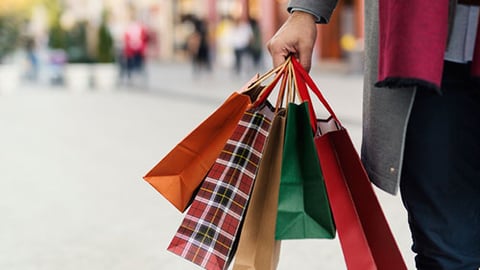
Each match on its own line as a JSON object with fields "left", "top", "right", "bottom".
{"left": 268, "top": 0, "right": 480, "bottom": 270}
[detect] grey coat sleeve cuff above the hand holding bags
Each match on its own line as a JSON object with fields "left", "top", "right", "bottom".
{"left": 287, "top": 0, "right": 338, "bottom": 23}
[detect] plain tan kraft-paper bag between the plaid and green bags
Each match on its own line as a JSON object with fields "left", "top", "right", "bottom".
{"left": 233, "top": 110, "right": 285, "bottom": 270}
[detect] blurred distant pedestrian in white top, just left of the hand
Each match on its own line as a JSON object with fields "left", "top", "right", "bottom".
{"left": 230, "top": 18, "right": 253, "bottom": 75}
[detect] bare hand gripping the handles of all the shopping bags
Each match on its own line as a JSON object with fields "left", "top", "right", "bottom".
{"left": 267, "top": 11, "right": 317, "bottom": 71}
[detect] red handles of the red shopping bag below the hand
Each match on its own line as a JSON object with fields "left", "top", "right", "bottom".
{"left": 291, "top": 59, "right": 342, "bottom": 131}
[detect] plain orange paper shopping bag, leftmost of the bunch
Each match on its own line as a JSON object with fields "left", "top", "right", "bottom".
{"left": 143, "top": 76, "right": 266, "bottom": 212}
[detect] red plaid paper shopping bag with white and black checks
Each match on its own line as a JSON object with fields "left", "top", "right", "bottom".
{"left": 168, "top": 106, "right": 273, "bottom": 269}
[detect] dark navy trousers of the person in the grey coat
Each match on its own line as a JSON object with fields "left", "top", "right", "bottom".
{"left": 400, "top": 62, "right": 480, "bottom": 270}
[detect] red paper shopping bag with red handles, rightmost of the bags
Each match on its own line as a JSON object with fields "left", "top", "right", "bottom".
{"left": 292, "top": 59, "right": 407, "bottom": 270}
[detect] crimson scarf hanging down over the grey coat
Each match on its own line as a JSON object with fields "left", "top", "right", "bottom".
{"left": 376, "top": 0, "right": 480, "bottom": 90}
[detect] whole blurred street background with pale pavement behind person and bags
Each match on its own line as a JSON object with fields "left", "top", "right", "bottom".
{"left": 0, "top": 0, "right": 413, "bottom": 270}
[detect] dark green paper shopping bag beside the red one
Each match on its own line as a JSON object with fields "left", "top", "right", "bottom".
{"left": 275, "top": 102, "right": 335, "bottom": 240}
